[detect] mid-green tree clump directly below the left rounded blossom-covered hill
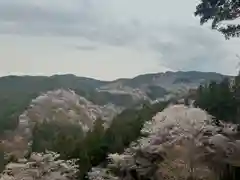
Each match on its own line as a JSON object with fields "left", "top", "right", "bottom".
{"left": 31, "top": 122, "right": 84, "bottom": 158}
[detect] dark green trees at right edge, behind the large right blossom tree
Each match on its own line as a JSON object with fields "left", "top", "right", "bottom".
{"left": 195, "top": 76, "right": 240, "bottom": 123}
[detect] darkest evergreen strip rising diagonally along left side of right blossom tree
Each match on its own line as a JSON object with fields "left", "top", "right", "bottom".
{"left": 75, "top": 103, "right": 167, "bottom": 178}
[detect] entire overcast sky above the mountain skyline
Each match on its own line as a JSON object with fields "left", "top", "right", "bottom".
{"left": 0, "top": 0, "right": 240, "bottom": 80}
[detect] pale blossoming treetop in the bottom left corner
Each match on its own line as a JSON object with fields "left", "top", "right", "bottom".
{"left": 0, "top": 151, "right": 78, "bottom": 180}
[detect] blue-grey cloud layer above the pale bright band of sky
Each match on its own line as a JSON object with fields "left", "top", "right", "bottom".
{"left": 0, "top": 0, "right": 240, "bottom": 76}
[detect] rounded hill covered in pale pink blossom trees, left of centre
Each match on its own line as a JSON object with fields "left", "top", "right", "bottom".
{"left": 2, "top": 89, "right": 122, "bottom": 156}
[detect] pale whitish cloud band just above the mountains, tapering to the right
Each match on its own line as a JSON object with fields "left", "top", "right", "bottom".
{"left": 0, "top": 35, "right": 169, "bottom": 80}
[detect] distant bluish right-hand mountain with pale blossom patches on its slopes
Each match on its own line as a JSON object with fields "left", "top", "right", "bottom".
{"left": 97, "top": 71, "right": 226, "bottom": 102}
